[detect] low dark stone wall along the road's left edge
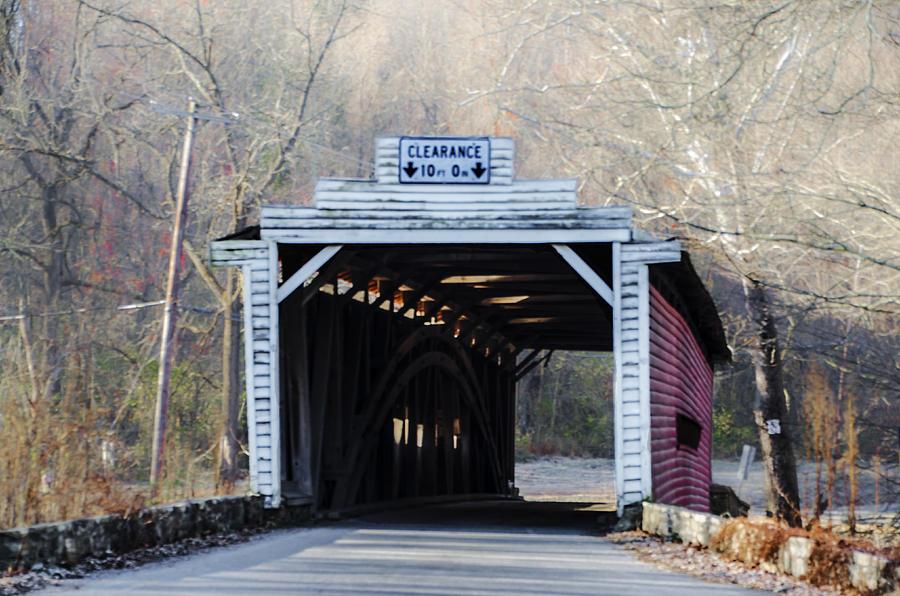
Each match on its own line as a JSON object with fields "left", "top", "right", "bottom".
{"left": 0, "top": 495, "right": 265, "bottom": 570}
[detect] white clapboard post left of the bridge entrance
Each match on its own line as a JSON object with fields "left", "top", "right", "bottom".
{"left": 210, "top": 240, "right": 281, "bottom": 507}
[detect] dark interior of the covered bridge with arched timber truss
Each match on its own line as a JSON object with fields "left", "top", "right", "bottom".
{"left": 279, "top": 242, "right": 612, "bottom": 510}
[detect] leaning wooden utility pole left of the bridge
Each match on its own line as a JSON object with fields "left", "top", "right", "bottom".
{"left": 150, "top": 99, "right": 197, "bottom": 485}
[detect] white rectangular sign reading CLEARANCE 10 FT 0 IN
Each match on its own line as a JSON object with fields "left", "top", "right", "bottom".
{"left": 398, "top": 137, "right": 491, "bottom": 184}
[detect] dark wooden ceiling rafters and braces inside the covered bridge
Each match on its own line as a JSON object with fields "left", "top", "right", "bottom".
{"left": 278, "top": 245, "right": 612, "bottom": 357}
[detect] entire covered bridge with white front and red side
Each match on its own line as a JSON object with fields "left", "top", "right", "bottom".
{"left": 211, "top": 137, "right": 728, "bottom": 511}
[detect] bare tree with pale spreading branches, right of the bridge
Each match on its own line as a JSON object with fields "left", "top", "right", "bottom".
{"left": 461, "top": 0, "right": 900, "bottom": 523}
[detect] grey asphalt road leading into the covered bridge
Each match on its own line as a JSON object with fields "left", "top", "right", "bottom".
{"left": 37, "top": 502, "right": 763, "bottom": 596}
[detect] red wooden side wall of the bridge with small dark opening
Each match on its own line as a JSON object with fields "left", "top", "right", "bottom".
{"left": 650, "top": 285, "right": 713, "bottom": 511}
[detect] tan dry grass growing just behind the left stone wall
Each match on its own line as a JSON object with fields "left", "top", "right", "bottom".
{"left": 0, "top": 370, "right": 236, "bottom": 529}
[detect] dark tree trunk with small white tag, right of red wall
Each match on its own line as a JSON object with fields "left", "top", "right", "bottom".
{"left": 744, "top": 279, "right": 802, "bottom": 527}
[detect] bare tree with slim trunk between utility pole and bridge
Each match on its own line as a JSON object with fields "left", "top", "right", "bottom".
{"left": 80, "top": 0, "right": 362, "bottom": 486}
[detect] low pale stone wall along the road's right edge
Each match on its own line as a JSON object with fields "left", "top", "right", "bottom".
{"left": 641, "top": 503, "right": 900, "bottom": 594}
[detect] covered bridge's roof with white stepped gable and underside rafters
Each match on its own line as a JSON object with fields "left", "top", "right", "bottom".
{"left": 212, "top": 137, "right": 728, "bottom": 362}
